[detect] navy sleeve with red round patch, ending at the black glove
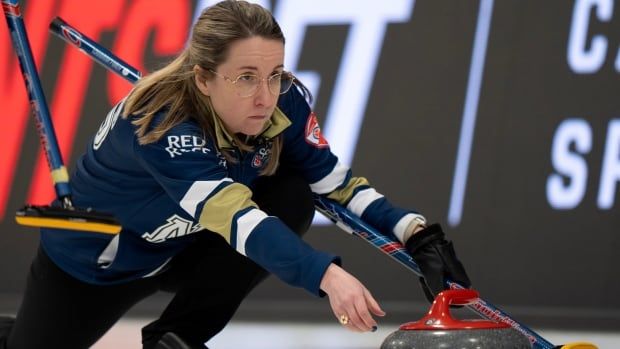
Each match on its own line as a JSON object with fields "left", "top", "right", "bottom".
{"left": 280, "top": 88, "right": 425, "bottom": 242}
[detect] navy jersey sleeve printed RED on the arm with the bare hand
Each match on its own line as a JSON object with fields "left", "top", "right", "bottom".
{"left": 135, "top": 118, "right": 340, "bottom": 295}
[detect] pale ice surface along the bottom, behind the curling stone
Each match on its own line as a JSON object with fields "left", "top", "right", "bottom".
{"left": 93, "top": 319, "right": 620, "bottom": 349}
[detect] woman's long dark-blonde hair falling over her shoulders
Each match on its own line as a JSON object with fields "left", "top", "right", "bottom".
{"left": 123, "top": 0, "right": 294, "bottom": 175}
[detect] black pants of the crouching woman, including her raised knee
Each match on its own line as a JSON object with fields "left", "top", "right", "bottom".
{"left": 0, "top": 175, "right": 314, "bottom": 349}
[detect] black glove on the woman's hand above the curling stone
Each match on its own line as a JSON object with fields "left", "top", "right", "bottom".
{"left": 405, "top": 224, "right": 471, "bottom": 303}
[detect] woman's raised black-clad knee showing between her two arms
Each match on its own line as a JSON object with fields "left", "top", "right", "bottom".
{"left": 253, "top": 174, "right": 314, "bottom": 235}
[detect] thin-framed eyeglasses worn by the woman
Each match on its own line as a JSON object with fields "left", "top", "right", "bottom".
{"left": 209, "top": 69, "right": 295, "bottom": 98}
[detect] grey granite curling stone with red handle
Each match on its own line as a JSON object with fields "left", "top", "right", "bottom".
{"left": 381, "top": 289, "right": 532, "bottom": 349}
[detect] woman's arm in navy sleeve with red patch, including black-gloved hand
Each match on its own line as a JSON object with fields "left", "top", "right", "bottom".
{"left": 280, "top": 85, "right": 470, "bottom": 301}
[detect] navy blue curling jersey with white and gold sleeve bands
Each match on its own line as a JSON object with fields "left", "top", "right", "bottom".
{"left": 41, "top": 88, "right": 426, "bottom": 294}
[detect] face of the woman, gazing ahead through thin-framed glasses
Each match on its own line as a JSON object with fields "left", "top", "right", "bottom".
{"left": 196, "top": 36, "right": 284, "bottom": 136}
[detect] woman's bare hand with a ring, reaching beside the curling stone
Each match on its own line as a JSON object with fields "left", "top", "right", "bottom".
{"left": 321, "top": 263, "right": 385, "bottom": 332}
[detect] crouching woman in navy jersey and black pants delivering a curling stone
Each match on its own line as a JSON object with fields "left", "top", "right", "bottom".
{"left": 0, "top": 1, "right": 469, "bottom": 349}
